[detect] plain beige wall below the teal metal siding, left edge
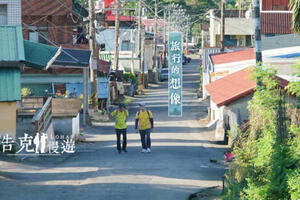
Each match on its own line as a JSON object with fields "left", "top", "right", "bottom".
{"left": 0, "top": 101, "right": 17, "bottom": 139}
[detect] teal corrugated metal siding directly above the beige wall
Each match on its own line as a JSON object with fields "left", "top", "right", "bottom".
{"left": 0, "top": 67, "right": 21, "bottom": 102}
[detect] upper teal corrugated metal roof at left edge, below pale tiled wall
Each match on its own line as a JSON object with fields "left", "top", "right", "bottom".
{"left": 0, "top": 26, "right": 25, "bottom": 64}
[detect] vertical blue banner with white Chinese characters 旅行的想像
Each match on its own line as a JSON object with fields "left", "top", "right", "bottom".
{"left": 168, "top": 32, "right": 182, "bottom": 117}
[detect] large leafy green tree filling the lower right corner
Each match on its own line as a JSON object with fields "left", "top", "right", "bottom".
{"left": 224, "top": 67, "right": 300, "bottom": 200}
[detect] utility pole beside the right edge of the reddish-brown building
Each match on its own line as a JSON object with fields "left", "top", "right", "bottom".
{"left": 89, "top": 0, "right": 98, "bottom": 110}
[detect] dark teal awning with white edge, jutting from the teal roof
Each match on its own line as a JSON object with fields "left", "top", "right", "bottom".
{"left": 24, "top": 40, "right": 61, "bottom": 69}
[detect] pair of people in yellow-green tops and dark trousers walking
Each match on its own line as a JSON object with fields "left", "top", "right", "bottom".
{"left": 111, "top": 103, "right": 153, "bottom": 154}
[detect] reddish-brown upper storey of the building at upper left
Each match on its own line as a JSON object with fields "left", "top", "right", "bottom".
{"left": 22, "top": 0, "right": 89, "bottom": 49}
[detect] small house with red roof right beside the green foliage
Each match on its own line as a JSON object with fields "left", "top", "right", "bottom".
{"left": 205, "top": 67, "right": 297, "bottom": 140}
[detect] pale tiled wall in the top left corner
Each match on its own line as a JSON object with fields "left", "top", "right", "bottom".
{"left": 0, "top": 0, "right": 22, "bottom": 25}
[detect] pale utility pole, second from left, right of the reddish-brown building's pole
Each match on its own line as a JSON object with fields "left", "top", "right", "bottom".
{"left": 114, "top": 0, "right": 120, "bottom": 70}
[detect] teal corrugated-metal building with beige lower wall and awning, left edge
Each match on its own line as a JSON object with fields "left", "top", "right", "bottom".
{"left": 0, "top": 25, "right": 60, "bottom": 139}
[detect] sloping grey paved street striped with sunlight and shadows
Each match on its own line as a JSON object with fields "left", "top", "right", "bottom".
{"left": 0, "top": 56, "right": 224, "bottom": 200}
